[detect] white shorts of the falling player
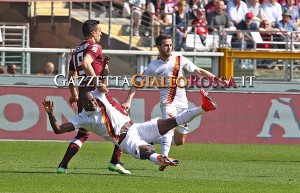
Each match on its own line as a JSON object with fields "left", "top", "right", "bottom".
{"left": 120, "top": 117, "right": 161, "bottom": 159}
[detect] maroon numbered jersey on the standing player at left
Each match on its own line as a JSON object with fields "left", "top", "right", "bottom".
{"left": 69, "top": 40, "right": 103, "bottom": 91}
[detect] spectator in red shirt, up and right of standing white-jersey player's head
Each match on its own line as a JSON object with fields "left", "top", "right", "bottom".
{"left": 192, "top": 8, "right": 208, "bottom": 45}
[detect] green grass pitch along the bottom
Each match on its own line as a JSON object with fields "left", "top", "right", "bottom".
{"left": 0, "top": 141, "right": 300, "bottom": 193}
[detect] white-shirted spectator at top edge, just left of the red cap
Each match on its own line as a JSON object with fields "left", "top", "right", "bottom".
{"left": 226, "top": 0, "right": 248, "bottom": 27}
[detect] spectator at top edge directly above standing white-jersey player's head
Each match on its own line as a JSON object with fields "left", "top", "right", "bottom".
{"left": 144, "top": 0, "right": 168, "bottom": 37}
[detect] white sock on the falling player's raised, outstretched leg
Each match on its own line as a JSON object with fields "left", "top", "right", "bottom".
{"left": 176, "top": 107, "right": 205, "bottom": 125}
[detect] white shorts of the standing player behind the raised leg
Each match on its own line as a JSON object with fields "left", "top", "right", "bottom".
{"left": 160, "top": 104, "right": 189, "bottom": 134}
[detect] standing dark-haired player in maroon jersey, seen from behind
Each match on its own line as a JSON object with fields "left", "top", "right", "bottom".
{"left": 57, "top": 20, "right": 130, "bottom": 174}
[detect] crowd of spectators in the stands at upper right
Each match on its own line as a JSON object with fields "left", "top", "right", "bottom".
{"left": 123, "top": 0, "right": 300, "bottom": 51}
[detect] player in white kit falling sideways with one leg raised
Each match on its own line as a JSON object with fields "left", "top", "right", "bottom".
{"left": 43, "top": 89, "right": 216, "bottom": 172}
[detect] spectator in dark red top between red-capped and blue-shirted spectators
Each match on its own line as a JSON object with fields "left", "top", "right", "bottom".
{"left": 256, "top": 19, "right": 279, "bottom": 49}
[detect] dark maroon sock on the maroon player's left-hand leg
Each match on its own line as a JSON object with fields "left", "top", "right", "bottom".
{"left": 59, "top": 131, "right": 90, "bottom": 168}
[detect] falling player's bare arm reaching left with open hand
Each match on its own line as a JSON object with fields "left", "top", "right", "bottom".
{"left": 42, "top": 100, "right": 75, "bottom": 134}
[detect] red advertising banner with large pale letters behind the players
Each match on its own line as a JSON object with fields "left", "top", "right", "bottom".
{"left": 0, "top": 86, "right": 300, "bottom": 144}
